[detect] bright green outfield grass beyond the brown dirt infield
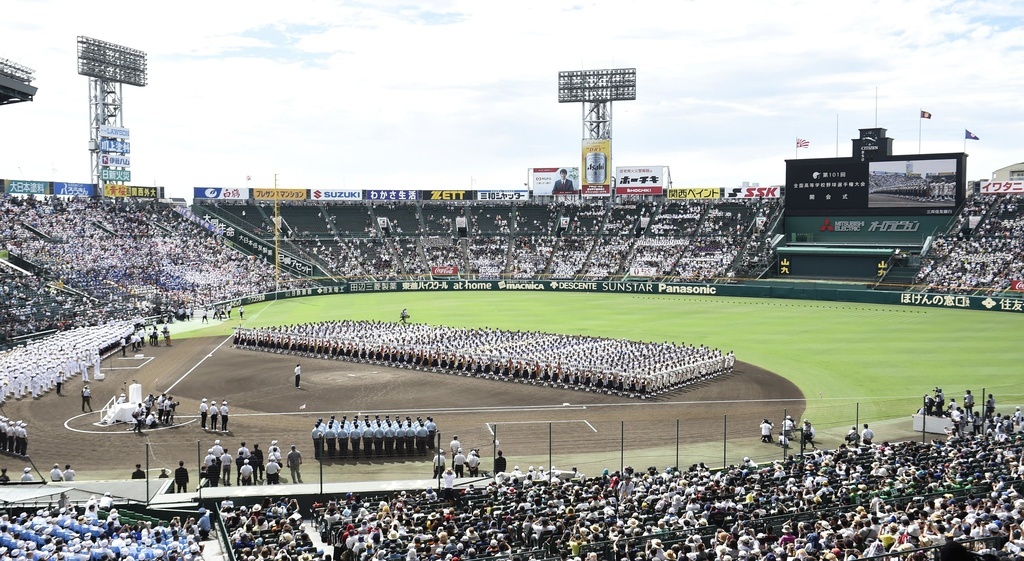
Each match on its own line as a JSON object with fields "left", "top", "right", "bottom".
{"left": 182, "top": 292, "right": 1024, "bottom": 427}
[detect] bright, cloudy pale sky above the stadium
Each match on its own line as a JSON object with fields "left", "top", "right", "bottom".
{"left": 0, "top": 0, "right": 1024, "bottom": 197}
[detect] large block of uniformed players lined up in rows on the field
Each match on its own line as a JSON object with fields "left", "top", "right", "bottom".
{"left": 233, "top": 320, "right": 735, "bottom": 398}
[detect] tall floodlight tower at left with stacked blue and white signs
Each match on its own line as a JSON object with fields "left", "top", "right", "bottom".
{"left": 78, "top": 36, "right": 148, "bottom": 192}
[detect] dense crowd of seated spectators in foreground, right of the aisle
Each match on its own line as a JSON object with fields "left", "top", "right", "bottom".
{"left": 282, "top": 429, "right": 1024, "bottom": 561}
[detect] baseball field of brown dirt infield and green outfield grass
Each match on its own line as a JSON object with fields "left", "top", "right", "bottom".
{"left": 4, "top": 292, "right": 1024, "bottom": 482}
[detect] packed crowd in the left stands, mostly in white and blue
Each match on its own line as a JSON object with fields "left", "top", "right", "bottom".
{"left": 0, "top": 196, "right": 311, "bottom": 337}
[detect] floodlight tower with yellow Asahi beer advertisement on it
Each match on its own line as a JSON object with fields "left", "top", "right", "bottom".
{"left": 558, "top": 69, "right": 637, "bottom": 196}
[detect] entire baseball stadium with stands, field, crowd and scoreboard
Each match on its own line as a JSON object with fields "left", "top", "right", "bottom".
{"left": 0, "top": 38, "right": 1024, "bottom": 561}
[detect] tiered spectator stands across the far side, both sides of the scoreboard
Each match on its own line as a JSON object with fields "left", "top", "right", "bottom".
{"left": 0, "top": 195, "right": 1024, "bottom": 344}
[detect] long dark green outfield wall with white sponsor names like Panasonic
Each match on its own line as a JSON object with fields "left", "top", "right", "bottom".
{"left": 219, "top": 281, "right": 1024, "bottom": 313}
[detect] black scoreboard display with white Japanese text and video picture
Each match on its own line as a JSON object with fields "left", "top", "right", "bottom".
{"left": 785, "top": 154, "right": 967, "bottom": 216}
